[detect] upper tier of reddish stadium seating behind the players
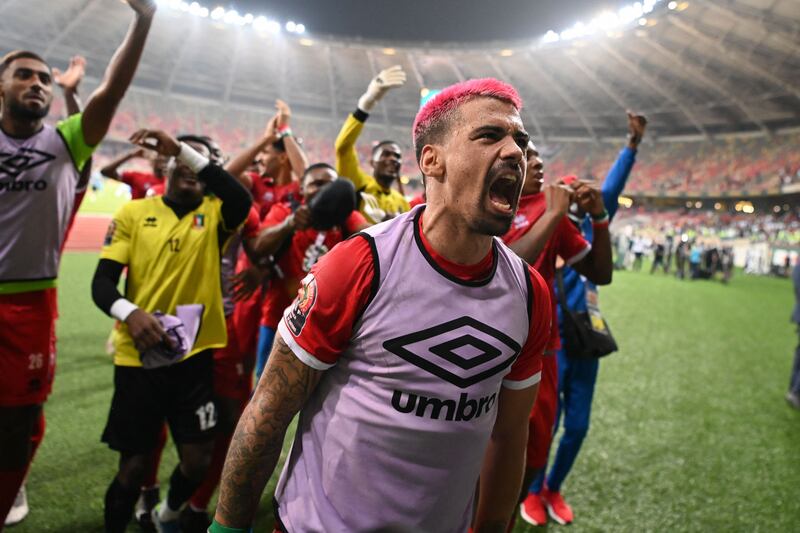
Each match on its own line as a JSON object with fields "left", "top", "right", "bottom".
{"left": 47, "top": 92, "right": 800, "bottom": 201}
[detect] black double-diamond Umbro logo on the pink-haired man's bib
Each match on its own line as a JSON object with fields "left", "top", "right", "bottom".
{"left": 383, "top": 316, "right": 522, "bottom": 389}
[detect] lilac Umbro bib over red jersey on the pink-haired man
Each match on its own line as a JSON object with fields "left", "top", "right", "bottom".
{"left": 275, "top": 206, "right": 552, "bottom": 533}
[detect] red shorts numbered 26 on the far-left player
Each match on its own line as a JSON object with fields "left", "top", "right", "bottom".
{"left": 0, "top": 289, "right": 58, "bottom": 407}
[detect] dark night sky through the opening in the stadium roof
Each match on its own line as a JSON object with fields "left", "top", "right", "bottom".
{"left": 222, "top": 0, "right": 620, "bottom": 42}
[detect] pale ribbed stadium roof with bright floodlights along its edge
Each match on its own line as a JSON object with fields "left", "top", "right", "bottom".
{"left": 0, "top": 0, "right": 800, "bottom": 140}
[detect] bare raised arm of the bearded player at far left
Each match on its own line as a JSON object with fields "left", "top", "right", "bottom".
{"left": 82, "top": 0, "right": 156, "bottom": 146}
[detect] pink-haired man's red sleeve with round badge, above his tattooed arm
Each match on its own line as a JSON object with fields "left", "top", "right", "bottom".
{"left": 278, "top": 237, "right": 375, "bottom": 370}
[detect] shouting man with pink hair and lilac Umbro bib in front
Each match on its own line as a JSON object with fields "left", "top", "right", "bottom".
{"left": 210, "top": 79, "right": 552, "bottom": 533}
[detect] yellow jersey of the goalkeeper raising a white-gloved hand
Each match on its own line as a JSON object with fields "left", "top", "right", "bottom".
{"left": 336, "top": 113, "right": 410, "bottom": 223}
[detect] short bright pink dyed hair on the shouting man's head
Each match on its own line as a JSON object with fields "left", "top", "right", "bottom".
{"left": 413, "top": 78, "right": 522, "bottom": 145}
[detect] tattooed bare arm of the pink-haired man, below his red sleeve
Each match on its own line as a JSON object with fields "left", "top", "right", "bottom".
{"left": 215, "top": 334, "right": 321, "bottom": 528}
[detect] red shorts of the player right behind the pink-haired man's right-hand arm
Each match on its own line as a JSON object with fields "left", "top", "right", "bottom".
{"left": 525, "top": 354, "right": 558, "bottom": 469}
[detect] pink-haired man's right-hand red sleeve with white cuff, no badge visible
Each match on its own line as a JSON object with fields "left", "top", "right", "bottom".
{"left": 503, "top": 266, "right": 553, "bottom": 389}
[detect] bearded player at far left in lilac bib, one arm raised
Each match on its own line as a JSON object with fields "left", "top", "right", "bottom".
{"left": 0, "top": 0, "right": 155, "bottom": 529}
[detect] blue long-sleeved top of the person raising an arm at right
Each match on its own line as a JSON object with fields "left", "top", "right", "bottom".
{"left": 556, "top": 146, "right": 636, "bottom": 324}
